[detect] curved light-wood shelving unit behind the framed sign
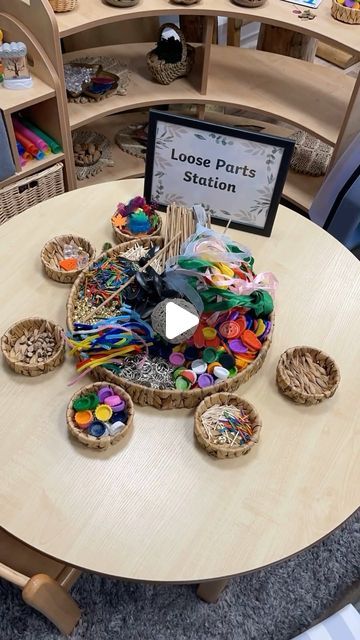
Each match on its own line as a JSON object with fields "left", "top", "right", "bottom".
{"left": 0, "top": 0, "right": 360, "bottom": 210}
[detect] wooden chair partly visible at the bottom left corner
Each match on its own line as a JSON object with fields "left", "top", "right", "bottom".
{"left": 0, "top": 528, "right": 81, "bottom": 634}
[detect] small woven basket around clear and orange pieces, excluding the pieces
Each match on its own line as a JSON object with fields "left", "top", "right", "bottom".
{"left": 41, "top": 235, "right": 96, "bottom": 284}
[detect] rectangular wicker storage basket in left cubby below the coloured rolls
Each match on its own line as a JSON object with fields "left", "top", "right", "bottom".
{"left": 0, "top": 163, "right": 65, "bottom": 224}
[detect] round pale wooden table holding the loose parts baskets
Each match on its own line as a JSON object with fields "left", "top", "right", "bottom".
{"left": 0, "top": 180, "right": 360, "bottom": 599}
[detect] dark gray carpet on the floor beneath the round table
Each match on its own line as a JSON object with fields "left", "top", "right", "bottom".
{"left": 0, "top": 511, "right": 360, "bottom": 640}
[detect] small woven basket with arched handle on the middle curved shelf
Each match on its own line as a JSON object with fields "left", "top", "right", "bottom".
{"left": 146, "top": 23, "right": 195, "bottom": 84}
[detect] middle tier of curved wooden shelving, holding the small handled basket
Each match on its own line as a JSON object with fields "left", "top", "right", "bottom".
{"left": 65, "top": 43, "right": 355, "bottom": 144}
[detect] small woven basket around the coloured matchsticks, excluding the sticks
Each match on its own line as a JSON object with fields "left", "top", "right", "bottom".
{"left": 194, "top": 393, "right": 262, "bottom": 459}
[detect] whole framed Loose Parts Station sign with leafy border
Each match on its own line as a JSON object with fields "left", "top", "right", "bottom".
{"left": 144, "top": 110, "right": 294, "bottom": 236}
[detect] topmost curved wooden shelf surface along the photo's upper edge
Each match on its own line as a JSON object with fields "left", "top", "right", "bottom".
{"left": 56, "top": 0, "right": 360, "bottom": 53}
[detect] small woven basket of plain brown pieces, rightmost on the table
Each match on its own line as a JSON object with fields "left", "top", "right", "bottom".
{"left": 276, "top": 347, "right": 340, "bottom": 404}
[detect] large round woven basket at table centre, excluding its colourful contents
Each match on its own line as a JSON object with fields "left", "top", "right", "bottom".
{"left": 67, "top": 237, "right": 274, "bottom": 409}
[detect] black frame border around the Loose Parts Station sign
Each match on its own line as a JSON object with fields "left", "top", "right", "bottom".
{"left": 144, "top": 109, "right": 294, "bottom": 236}
